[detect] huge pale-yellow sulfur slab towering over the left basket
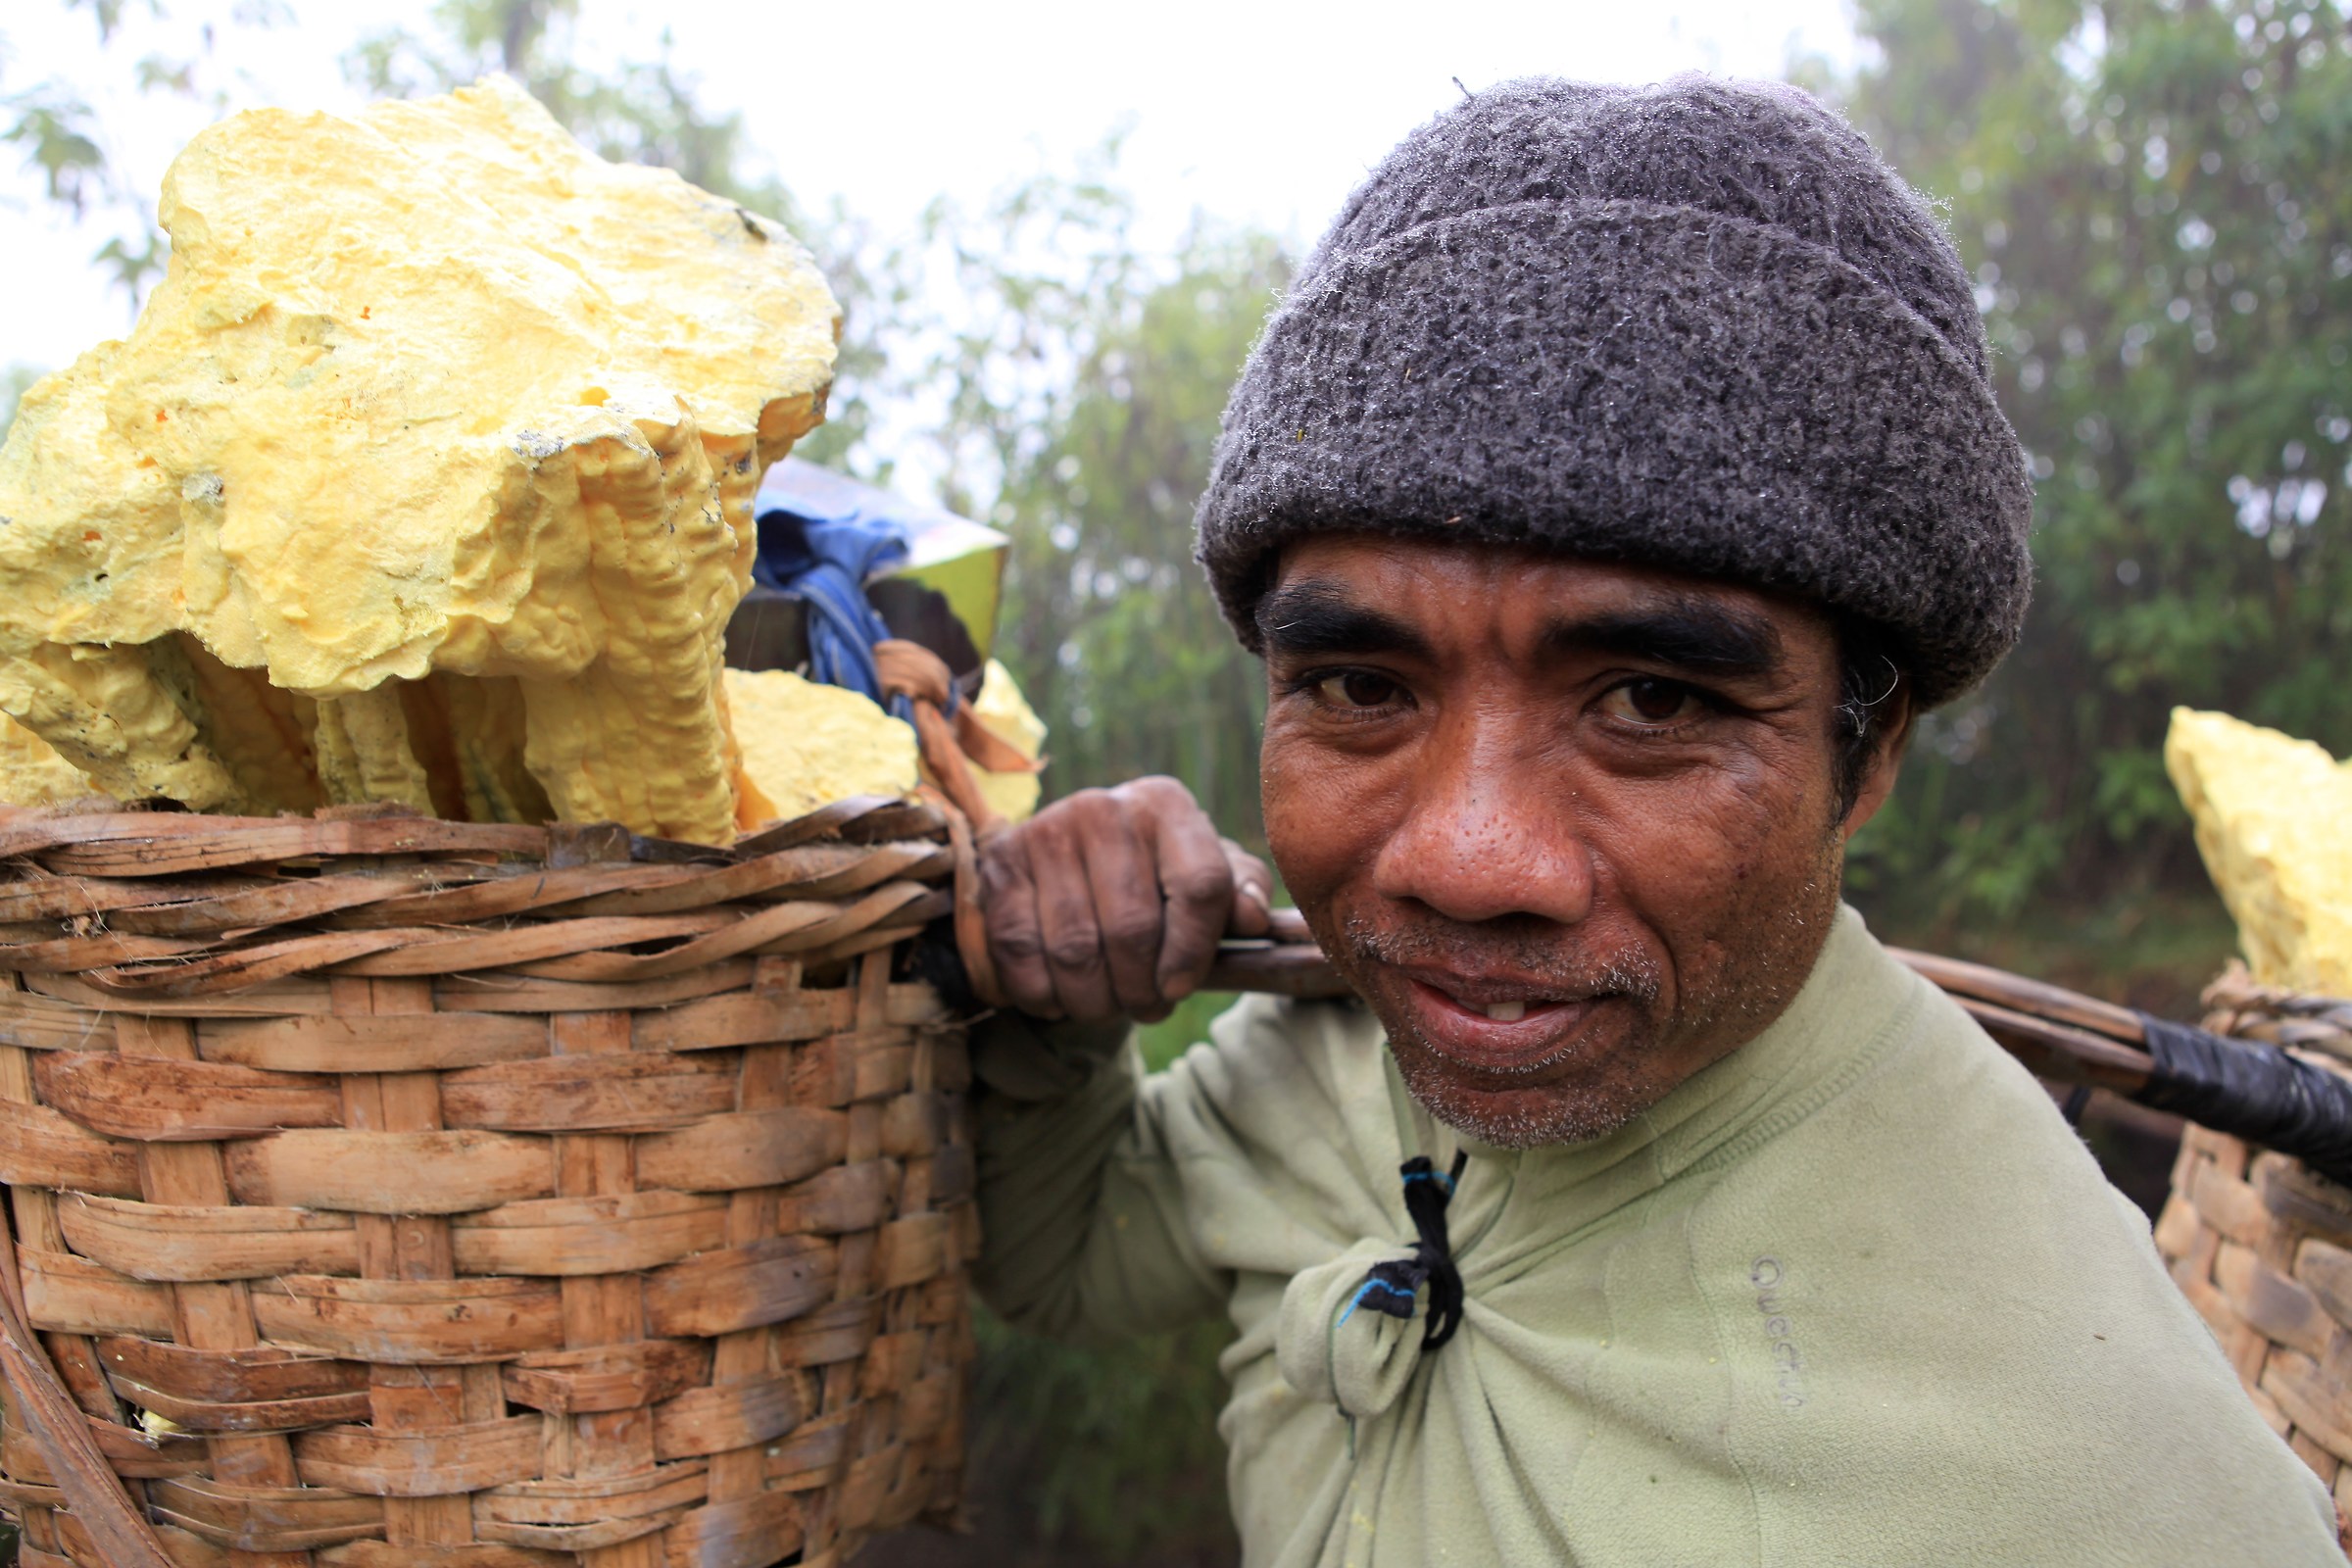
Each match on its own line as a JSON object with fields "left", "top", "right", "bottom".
{"left": 0, "top": 80, "right": 840, "bottom": 842}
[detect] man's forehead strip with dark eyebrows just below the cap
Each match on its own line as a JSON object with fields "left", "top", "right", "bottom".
{"left": 1256, "top": 538, "right": 1821, "bottom": 677}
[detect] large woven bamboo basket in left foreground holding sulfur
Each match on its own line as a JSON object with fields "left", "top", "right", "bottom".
{"left": 0, "top": 800, "right": 978, "bottom": 1568}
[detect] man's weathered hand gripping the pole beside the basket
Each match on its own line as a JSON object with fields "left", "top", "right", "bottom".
{"left": 981, "top": 778, "right": 1272, "bottom": 1022}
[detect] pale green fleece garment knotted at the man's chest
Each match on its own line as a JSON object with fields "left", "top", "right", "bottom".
{"left": 976, "top": 909, "right": 2345, "bottom": 1568}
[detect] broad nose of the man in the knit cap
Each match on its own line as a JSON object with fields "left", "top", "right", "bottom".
{"left": 1371, "top": 724, "right": 1594, "bottom": 924}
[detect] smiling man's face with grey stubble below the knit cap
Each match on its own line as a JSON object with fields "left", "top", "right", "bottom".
{"left": 1258, "top": 536, "right": 1893, "bottom": 1148}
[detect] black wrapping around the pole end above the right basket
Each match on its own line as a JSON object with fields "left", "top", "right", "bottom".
{"left": 2131, "top": 1013, "right": 2352, "bottom": 1187}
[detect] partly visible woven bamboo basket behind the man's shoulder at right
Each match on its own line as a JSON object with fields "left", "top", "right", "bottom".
{"left": 2157, "top": 964, "right": 2352, "bottom": 1514}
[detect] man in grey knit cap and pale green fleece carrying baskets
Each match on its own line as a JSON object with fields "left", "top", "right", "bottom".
{"left": 976, "top": 77, "right": 2342, "bottom": 1568}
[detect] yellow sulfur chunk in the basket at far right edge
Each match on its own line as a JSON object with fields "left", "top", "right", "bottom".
{"left": 2164, "top": 708, "right": 2352, "bottom": 997}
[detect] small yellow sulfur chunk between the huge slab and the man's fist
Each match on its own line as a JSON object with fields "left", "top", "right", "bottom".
{"left": 727, "top": 670, "right": 917, "bottom": 827}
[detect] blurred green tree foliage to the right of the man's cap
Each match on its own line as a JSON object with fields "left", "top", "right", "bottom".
{"left": 1846, "top": 0, "right": 2352, "bottom": 921}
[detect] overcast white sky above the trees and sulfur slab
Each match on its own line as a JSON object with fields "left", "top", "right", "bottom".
{"left": 0, "top": 0, "right": 1853, "bottom": 367}
